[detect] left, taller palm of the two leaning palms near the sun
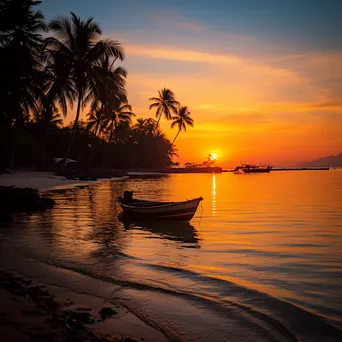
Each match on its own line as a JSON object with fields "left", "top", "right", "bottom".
{"left": 149, "top": 88, "right": 179, "bottom": 134}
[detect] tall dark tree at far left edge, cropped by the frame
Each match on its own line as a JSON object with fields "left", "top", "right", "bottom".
{"left": 0, "top": 0, "right": 45, "bottom": 168}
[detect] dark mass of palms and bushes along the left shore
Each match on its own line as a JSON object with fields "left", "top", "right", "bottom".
{"left": 0, "top": 0, "right": 193, "bottom": 171}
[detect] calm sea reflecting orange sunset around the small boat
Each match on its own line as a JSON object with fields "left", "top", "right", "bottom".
{"left": 0, "top": 170, "right": 342, "bottom": 341}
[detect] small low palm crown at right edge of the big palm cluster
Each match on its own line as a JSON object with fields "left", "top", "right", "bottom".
{"left": 106, "top": 100, "right": 135, "bottom": 143}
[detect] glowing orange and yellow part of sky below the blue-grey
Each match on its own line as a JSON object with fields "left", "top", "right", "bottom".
{"left": 122, "top": 45, "right": 342, "bottom": 166}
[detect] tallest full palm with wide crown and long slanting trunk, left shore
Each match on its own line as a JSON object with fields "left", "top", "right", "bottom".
{"left": 47, "top": 12, "right": 124, "bottom": 169}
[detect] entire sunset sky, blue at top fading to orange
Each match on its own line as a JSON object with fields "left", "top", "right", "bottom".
{"left": 40, "top": 0, "right": 342, "bottom": 167}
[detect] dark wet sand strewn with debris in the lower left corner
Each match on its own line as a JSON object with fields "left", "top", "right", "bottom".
{"left": 0, "top": 269, "right": 166, "bottom": 342}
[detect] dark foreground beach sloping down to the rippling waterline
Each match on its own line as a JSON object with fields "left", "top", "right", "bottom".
{"left": 0, "top": 244, "right": 168, "bottom": 342}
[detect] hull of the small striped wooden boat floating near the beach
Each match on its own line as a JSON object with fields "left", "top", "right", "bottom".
{"left": 117, "top": 197, "right": 203, "bottom": 221}
